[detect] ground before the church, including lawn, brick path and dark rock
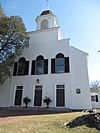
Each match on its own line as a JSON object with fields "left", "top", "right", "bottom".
{"left": 0, "top": 108, "right": 100, "bottom": 133}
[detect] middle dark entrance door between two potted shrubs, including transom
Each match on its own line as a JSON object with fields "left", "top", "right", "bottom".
{"left": 34, "top": 86, "right": 42, "bottom": 106}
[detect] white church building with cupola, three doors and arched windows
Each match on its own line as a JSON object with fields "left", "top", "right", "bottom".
{"left": 0, "top": 10, "right": 91, "bottom": 109}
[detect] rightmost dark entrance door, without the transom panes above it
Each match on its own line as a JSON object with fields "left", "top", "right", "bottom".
{"left": 56, "top": 89, "right": 65, "bottom": 107}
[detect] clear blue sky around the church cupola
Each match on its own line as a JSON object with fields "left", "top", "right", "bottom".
{"left": 0, "top": 0, "right": 100, "bottom": 82}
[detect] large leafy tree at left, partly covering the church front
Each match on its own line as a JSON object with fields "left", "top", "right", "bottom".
{"left": 0, "top": 7, "right": 29, "bottom": 84}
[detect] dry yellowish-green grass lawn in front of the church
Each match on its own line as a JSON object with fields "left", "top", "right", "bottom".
{"left": 0, "top": 112, "right": 100, "bottom": 133}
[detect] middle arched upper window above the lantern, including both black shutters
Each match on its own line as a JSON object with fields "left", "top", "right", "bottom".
{"left": 31, "top": 55, "right": 48, "bottom": 75}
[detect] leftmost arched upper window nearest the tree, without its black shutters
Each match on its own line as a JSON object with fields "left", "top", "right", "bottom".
{"left": 17, "top": 57, "right": 26, "bottom": 75}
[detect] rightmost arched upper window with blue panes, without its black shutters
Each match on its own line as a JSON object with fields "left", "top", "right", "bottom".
{"left": 55, "top": 53, "right": 65, "bottom": 73}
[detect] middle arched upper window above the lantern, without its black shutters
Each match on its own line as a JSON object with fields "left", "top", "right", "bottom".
{"left": 36, "top": 55, "right": 44, "bottom": 74}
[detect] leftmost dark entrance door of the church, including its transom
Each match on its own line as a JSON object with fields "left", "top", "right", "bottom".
{"left": 14, "top": 86, "right": 23, "bottom": 106}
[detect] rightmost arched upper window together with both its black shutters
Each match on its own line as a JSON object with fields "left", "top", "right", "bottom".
{"left": 51, "top": 53, "right": 69, "bottom": 73}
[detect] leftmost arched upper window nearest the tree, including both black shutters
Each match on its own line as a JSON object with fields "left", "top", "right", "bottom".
{"left": 13, "top": 57, "right": 29, "bottom": 76}
